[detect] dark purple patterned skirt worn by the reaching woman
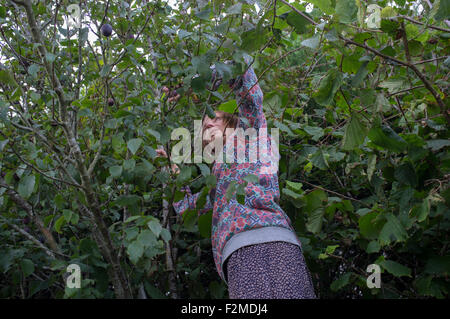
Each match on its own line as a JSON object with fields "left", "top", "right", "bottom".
{"left": 225, "top": 241, "right": 316, "bottom": 299}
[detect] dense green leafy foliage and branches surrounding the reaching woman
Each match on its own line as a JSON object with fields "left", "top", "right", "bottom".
{"left": 0, "top": 0, "right": 450, "bottom": 298}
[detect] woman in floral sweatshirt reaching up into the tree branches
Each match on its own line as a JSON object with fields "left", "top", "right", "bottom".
{"left": 158, "top": 55, "right": 315, "bottom": 299}
